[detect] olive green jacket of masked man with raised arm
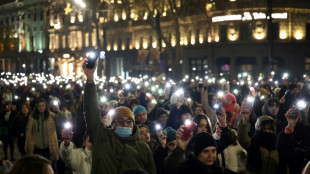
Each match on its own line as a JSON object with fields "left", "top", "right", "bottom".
{"left": 84, "top": 83, "right": 156, "bottom": 174}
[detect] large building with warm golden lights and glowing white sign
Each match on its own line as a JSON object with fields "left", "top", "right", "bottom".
{"left": 0, "top": 0, "right": 310, "bottom": 78}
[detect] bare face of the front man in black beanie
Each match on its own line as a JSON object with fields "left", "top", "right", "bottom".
{"left": 197, "top": 146, "right": 216, "bottom": 166}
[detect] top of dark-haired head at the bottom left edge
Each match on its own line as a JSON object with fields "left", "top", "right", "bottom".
{"left": 7, "top": 155, "right": 51, "bottom": 174}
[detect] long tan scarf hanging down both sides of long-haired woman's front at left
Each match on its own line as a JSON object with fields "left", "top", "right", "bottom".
{"left": 25, "top": 112, "right": 59, "bottom": 160}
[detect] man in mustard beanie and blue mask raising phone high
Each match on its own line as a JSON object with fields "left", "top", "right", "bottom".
{"left": 83, "top": 61, "right": 156, "bottom": 174}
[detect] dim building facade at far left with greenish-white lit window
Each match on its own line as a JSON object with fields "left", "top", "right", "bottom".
{"left": 0, "top": 0, "right": 48, "bottom": 73}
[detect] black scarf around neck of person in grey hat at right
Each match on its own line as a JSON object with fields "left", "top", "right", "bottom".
{"left": 247, "top": 130, "right": 277, "bottom": 172}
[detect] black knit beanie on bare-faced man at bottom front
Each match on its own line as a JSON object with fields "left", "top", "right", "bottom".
{"left": 192, "top": 132, "right": 216, "bottom": 157}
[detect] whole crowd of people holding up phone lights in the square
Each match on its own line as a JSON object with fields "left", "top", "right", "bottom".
{"left": 0, "top": 60, "right": 310, "bottom": 174}
